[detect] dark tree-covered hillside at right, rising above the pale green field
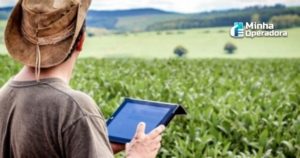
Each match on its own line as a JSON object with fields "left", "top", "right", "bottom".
{"left": 147, "top": 4, "right": 300, "bottom": 31}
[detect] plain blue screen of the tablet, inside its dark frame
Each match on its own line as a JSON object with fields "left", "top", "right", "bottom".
{"left": 108, "top": 102, "right": 171, "bottom": 143}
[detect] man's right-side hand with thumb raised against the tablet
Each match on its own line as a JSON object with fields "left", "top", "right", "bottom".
{"left": 125, "top": 122, "right": 165, "bottom": 158}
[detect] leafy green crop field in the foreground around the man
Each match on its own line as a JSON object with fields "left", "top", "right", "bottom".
{"left": 0, "top": 55, "right": 300, "bottom": 158}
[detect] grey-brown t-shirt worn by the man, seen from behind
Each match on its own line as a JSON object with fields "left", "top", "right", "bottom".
{"left": 0, "top": 78, "right": 113, "bottom": 158}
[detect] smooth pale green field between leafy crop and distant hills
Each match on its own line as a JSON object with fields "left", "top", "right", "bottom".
{"left": 0, "top": 22, "right": 300, "bottom": 59}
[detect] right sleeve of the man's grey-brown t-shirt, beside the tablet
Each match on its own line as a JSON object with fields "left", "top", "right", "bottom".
{"left": 63, "top": 116, "right": 113, "bottom": 158}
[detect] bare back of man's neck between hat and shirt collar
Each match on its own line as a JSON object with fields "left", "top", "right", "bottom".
{"left": 13, "top": 53, "right": 76, "bottom": 84}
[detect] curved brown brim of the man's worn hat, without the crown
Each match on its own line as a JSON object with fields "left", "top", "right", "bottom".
{"left": 4, "top": 1, "right": 85, "bottom": 68}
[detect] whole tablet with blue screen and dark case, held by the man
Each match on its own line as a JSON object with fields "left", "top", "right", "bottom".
{"left": 107, "top": 98, "right": 186, "bottom": 144}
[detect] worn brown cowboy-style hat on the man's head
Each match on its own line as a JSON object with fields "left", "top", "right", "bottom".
{"left": 5, "top": 0, "right": 91, "bottom": 71}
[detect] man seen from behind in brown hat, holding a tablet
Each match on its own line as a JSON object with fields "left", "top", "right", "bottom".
{"left": 0, "top": 0, "right": 164, "bottom": 158}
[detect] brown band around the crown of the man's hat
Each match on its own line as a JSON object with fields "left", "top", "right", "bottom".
{"left": 21, "top": 22, "right": 76, "bottom": 45}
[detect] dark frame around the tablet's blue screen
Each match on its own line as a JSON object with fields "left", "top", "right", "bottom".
{"left": 106, "top": 98, "right": 179, "bottom": 144}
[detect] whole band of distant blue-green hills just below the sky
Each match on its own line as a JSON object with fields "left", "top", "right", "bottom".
{"left": 82, "top": 5, "right": 300, "bottom": 32}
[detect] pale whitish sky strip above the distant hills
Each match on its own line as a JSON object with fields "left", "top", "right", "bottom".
{"left": 0, "top": 0, "right": 300, "bottom": 13}
